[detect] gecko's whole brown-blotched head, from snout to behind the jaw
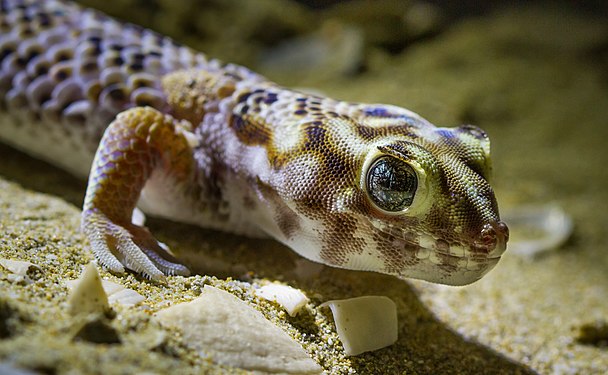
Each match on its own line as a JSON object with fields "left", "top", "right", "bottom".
{"left": 266, "top": 103, "right": 508, "bottom": 285}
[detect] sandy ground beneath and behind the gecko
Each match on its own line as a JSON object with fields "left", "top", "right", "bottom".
{"left": 0, "top": 2, "right": 608, "bottom": 374}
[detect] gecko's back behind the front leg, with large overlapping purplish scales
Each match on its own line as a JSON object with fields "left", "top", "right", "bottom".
{"left": 0, "top": 0, "right": 256, "bottom": 177}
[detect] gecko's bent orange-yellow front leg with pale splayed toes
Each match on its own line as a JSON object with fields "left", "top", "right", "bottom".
{"left": 82, "top": 107, "right": 194, "bottom": 279}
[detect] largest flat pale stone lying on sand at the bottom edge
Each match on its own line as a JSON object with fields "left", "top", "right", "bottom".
{"left": 156, "top": 286, "right": 322, "bottom": 374}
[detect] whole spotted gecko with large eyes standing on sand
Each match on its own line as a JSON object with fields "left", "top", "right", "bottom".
{"left": 0, "top": 0, "right": 508, "bottom": 285}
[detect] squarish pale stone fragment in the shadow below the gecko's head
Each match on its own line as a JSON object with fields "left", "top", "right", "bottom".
{"left": 322, "top": 296, "right": 398, "bottom": 356}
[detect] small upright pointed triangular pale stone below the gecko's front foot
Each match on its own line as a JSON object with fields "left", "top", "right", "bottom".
{"left": 68, "top": 263, "right": 110, "bottom": 315}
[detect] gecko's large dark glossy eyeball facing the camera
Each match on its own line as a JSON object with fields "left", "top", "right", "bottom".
{"left": 367, "top": 156, "right": 418, "bottom": 212}
